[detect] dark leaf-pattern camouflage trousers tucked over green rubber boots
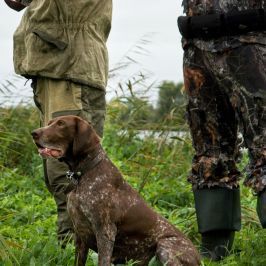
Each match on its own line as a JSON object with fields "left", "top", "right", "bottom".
{"left": 184, "top": 44, "right": 266, "bottom": 193}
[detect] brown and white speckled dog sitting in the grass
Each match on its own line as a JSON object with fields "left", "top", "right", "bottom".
{"left": 32, "top": 116, "right": 200, "bottom": 266}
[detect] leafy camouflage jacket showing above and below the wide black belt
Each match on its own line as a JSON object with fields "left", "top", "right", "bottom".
{"left": 182, "top": 0, "right": 266, "bottom": 52}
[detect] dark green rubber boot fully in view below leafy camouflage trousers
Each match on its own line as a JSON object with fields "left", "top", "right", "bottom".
{"left": 194, "top": 188, "right": 241, "bottom": 261}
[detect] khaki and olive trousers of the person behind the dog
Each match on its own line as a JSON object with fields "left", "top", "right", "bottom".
{"left": 32, "top": 78, "right": 106, "bottom": 240}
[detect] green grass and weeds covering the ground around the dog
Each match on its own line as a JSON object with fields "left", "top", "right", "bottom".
{"left": 0, "top": 83, "right": 266, "bottom": 266}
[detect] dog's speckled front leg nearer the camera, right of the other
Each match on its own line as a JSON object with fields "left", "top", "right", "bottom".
{"left": 96, "top": 224, "right": 117, "bottom": 266}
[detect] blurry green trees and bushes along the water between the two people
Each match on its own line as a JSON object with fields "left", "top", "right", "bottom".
{"left": 110, "top": 81, "right": 186, "bottom": 130}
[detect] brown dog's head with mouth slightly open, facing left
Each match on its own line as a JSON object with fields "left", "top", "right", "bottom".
{"left": 31, "top": 115, "right": 100, "bottom": 161}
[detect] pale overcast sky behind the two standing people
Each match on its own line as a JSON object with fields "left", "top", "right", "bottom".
{"left": 0, "top": 0, "right": 185, "bottom": 102}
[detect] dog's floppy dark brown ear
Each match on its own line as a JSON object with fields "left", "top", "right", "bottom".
{"left": 73, "top": 118, "right": 100, "bottom": 157}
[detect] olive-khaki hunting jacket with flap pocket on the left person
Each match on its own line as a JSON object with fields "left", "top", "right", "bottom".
{"left": 14, "top": 0, "right": 112, "bottom": 89}
